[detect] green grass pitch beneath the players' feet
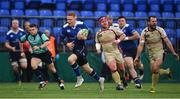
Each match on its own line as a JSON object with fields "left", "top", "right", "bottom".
{"left": 0, "top": 83, "right": 180, "bottom": 99}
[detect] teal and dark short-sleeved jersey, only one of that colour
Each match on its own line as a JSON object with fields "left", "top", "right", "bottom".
{"left": 20, "top": 32, "right": 49, "bottom": 54}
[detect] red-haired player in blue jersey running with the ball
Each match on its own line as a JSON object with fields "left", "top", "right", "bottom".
{"left": 61, "top": 12, "right": 104, "bottom": 91}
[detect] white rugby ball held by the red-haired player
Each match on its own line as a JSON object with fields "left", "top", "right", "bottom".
{"left": 77, "top": 29, "right": 88, "bottom": 40}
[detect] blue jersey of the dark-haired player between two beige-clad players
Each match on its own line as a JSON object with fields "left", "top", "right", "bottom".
{"left": 120, "top": 24, "right": 138, "bottom": 52}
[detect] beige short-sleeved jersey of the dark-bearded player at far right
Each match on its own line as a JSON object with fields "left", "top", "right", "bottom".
{"left": 140, "top": 26, "right": 167, "bottom": 51}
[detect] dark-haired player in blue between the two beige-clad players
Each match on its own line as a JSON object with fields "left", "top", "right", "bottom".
{"left": 118, "top": 16, "right": 141, "bottom": 88}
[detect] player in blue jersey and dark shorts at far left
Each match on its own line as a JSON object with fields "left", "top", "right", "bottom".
{"left": 5, "top": 19, "right": 27, "bottom": 84}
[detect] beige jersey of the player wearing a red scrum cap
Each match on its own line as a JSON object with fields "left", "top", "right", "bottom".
{"left": 95, "top": 29, "right": 123, "bottom": 52}
